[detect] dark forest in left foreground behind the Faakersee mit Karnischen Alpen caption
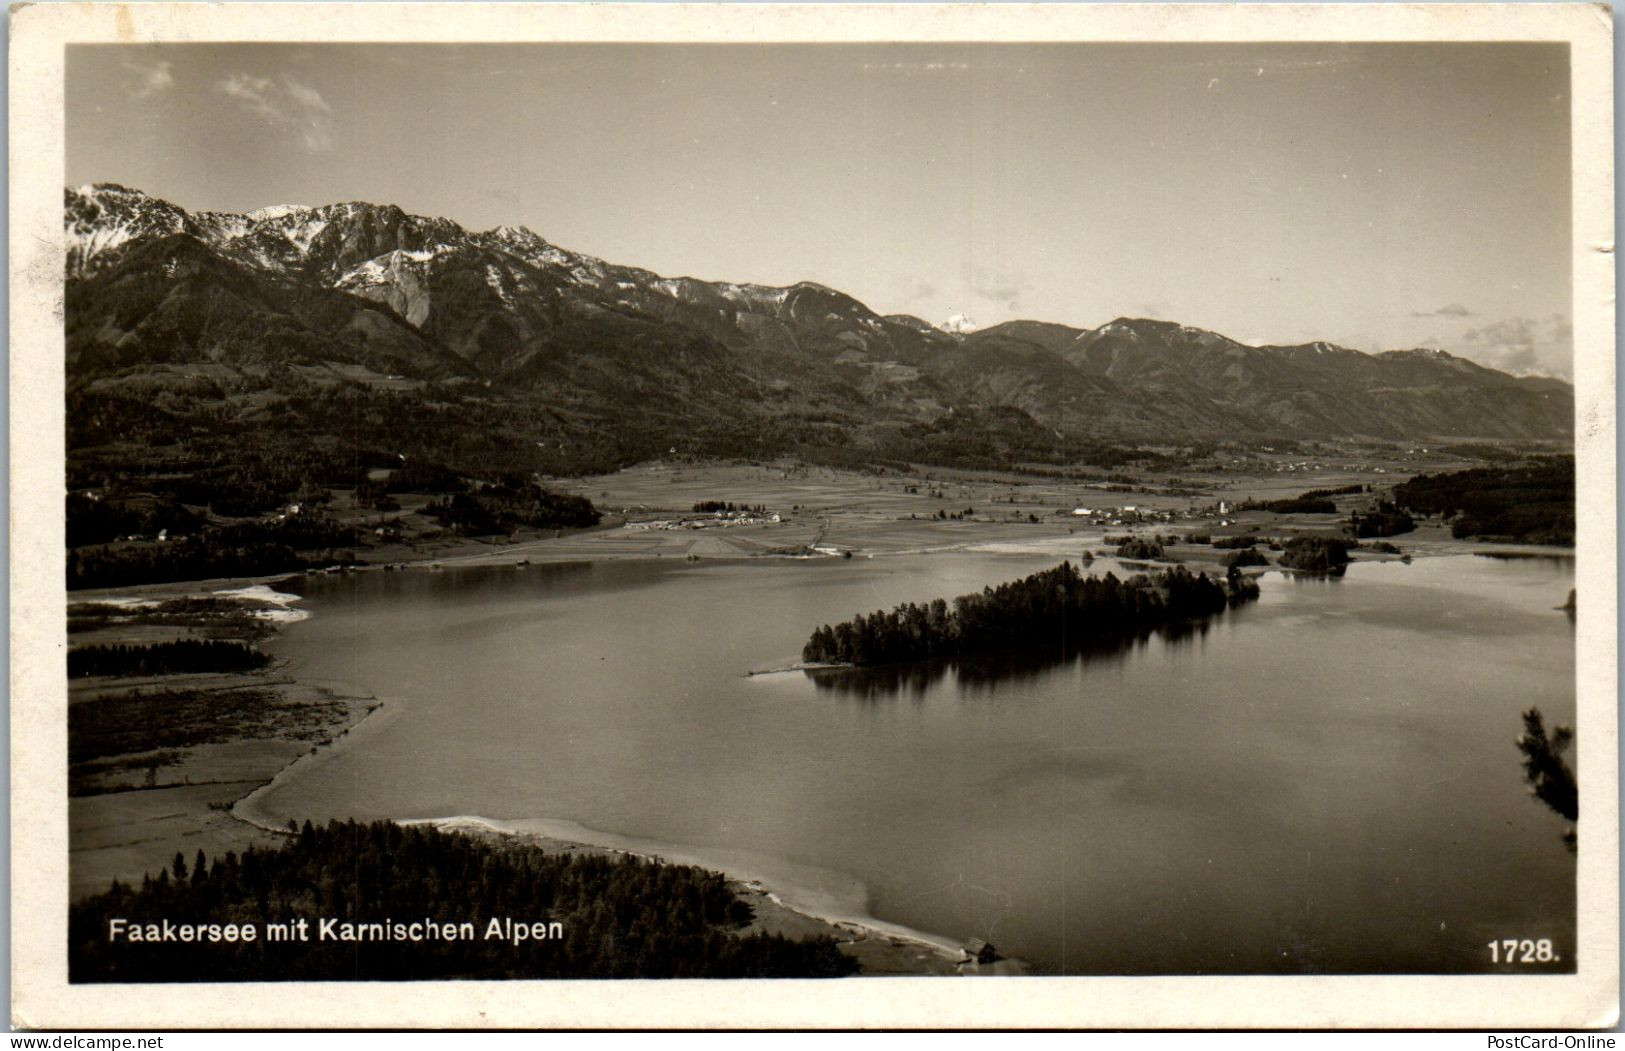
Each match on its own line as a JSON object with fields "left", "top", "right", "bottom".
{"left": 68, "top": 820, "right": 858, "bottom": 983}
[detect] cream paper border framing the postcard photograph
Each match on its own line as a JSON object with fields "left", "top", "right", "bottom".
{"left": 10, "top": 3, "right": 1619, "bottom": 1028}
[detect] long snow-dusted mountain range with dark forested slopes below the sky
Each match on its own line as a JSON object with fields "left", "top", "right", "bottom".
{"left": 65, "top": 184, "right": 1573, "bottom": 474}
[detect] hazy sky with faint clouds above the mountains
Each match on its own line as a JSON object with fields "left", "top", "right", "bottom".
{"left": 67, "top": 44, "right": 1573, "bottom": 377}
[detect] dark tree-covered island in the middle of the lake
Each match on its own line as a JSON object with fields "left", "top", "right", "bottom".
{"left": 801, "top": 562, "right": 1258, "bottom": 666}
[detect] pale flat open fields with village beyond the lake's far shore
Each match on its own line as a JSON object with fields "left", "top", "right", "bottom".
{"left": 383, "top": 455, "right": 1508, "bottom": 565}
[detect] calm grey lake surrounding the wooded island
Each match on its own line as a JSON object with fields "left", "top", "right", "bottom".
{"left": 254, "top": 551, "right": 1584, "bottom": 975}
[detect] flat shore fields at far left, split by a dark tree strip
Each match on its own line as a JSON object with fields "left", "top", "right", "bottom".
{"left": 67, "top": 597, "right": 379, "bottom": 898}
